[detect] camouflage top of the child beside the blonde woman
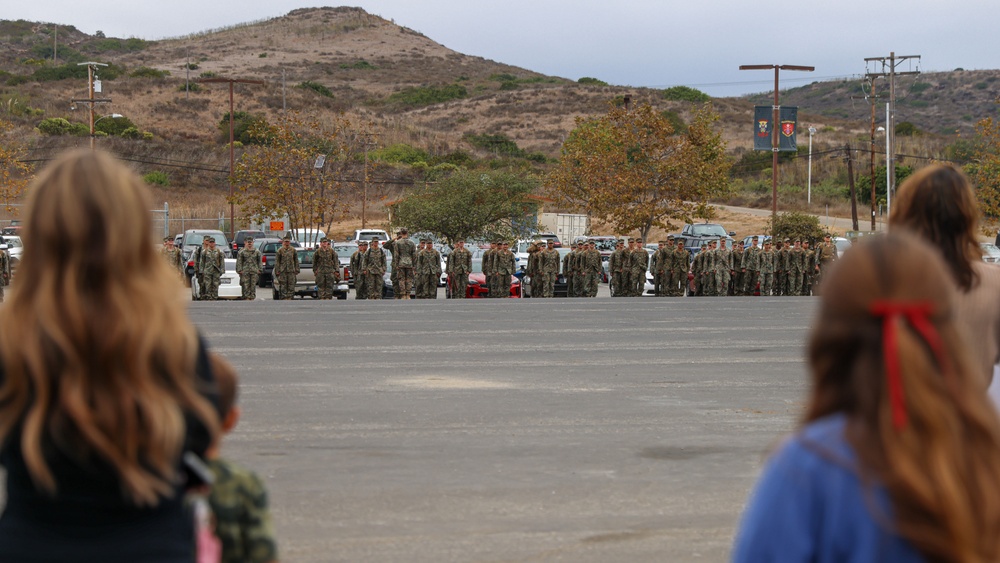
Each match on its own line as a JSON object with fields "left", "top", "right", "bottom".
{"left": 207, "top": 459, "right": 278, "bottom": 563}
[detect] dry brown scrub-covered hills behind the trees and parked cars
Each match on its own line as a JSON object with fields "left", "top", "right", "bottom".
{"left": 0, "top": 7, "right": 988, "bottom": 234}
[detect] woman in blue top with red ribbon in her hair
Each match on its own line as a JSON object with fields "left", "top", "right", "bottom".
{"left": 733, "top": 230, "right": 1000, "bottom": 563}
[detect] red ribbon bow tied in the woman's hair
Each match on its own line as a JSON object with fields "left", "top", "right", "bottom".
{"left": 869, "top": 301, "right": 946, "bottom": 429}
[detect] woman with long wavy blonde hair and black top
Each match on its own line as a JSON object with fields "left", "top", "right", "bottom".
{"left": 0, "top": 151, "right": 218, "bottom": 562}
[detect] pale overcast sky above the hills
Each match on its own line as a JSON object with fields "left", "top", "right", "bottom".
{"left": 0, "top": 0, "right": 1000, "bottom": 96}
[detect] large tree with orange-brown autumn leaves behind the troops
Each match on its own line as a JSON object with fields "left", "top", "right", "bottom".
{"left": 547, "top": 104, "right": 731, "bottom": 239}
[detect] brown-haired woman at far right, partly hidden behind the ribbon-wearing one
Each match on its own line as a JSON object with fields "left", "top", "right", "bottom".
{"left": 889, "top": 164, "right": 1000, "bottom": 384}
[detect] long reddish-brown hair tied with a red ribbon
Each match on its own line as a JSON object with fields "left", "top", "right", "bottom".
{"left": 804, "top": 229, "right": 1000, "bottom": 562}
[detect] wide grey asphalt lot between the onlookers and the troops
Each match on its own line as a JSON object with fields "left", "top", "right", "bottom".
{"left": 191, "top": 298, "right": 817, "bottom": 562}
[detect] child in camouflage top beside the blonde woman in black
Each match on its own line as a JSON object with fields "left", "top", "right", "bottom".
{"left": 205, "top": 354, "right": 278, "bottom": 563}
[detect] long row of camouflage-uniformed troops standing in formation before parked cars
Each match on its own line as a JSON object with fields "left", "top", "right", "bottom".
{"left": 166, "top": 229, "right": 837, "bottom": 300}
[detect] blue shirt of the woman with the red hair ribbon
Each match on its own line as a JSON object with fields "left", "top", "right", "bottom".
{"left": 732, "top": 415, "right": 924, "bottom": 563}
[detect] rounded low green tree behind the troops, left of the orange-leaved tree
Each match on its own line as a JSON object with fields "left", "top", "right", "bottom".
{"left": 393, "top": 170, "right": 539, "bottom": 242}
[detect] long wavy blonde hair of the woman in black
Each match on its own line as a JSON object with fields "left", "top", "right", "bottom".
{"left": 0, "top": 151, "right": 218, "bottom": 506}
